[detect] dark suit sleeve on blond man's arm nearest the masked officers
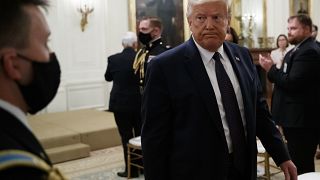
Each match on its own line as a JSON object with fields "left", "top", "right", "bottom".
{"left": 141, "top": 59, "right": 172, "bottom": 180}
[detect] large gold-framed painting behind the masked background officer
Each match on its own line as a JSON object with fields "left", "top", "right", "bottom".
{"left": 128, "top": 0, "right": 191, "bottom": 47}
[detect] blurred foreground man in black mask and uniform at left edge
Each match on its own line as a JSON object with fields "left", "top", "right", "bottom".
{"left": 0, "top": 0, "right": 60, "bottom": 179}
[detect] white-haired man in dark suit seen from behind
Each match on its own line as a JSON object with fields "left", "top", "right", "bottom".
{"left": 104, "top": 32, "right": 141, "bottom": 177}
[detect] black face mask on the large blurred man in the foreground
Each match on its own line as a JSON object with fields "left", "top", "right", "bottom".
{"left": 18, "top": 53, "right": 61, "bottom": 114}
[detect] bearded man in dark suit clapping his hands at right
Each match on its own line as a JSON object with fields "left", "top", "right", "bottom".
{"left": 260, "top": 15, "right": 320, "bottom": 174}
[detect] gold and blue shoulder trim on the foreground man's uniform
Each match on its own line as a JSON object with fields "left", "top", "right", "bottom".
{"left": 0, "top": 150, "right": 67, "bottom": 180}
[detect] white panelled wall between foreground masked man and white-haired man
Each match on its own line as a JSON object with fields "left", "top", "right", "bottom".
{"left": 44, "top": 0, "right": 128, "bottom": 112}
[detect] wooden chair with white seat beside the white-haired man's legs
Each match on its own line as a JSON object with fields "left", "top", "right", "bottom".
{"left": 127, "top": 136, "right": 143, "bottom": 179}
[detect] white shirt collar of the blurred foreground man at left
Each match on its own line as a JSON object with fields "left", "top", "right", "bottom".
{"left": 0, "top": 99, "right": 31, "bottom": 130}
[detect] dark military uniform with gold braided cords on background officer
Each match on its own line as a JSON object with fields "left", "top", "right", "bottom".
{"left": 133, "top": 38, "right": 169, "bottom": 92}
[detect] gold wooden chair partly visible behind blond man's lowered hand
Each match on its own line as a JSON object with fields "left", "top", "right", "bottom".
{"left": 257, "top": 139, "right": 282, "bottom": 180}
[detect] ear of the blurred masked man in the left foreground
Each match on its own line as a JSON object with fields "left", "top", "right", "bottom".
{"left": 2, "top": 48, "right": 21, "bottom": 80}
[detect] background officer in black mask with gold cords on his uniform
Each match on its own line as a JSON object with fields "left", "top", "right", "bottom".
{"left": 133, "top": 17, "right": 168, "bottom": 92}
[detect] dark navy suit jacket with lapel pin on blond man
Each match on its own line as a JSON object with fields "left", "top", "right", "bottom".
{"left": 142, "top": 38, "right": 289, "bottom": 180}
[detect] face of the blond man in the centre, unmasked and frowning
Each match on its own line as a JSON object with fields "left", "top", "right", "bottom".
{"left": 188, "top": 1, "right": 229, "bottom": 52}
